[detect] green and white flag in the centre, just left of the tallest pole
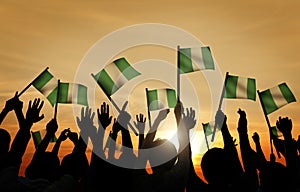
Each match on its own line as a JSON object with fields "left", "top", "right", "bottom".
{"left": 146, "top": 89, "right": 177, "bottom": 111}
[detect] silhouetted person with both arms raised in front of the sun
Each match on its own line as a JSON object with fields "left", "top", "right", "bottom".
{"left": 134, "top": 102, "right": 190, "bottom": 192}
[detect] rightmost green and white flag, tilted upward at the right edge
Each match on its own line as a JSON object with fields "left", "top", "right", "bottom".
{"left": 259, "top": 83, "right": 296, "bottom": 115}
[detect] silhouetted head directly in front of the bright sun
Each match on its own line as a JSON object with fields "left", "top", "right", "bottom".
{"left": 148, "top": 139, "right": 177, "bottom": 174}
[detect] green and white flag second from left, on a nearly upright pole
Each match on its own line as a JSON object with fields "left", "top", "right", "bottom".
{"left": 57, "top": 83, "right": 88, "bottom": 106}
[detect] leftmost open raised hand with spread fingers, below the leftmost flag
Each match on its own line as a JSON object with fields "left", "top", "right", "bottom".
{"left": 26, "top": 98, "right": 44, "bottom": 123}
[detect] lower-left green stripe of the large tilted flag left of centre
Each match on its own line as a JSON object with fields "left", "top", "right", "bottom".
{"left": 95, "top": 70, "right": 117, "bottom": 97}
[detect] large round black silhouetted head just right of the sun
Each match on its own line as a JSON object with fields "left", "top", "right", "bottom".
{"left": 201, "top": 147, "right": 233, "bottom": 185}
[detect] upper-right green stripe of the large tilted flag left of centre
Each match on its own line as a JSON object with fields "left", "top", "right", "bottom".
{"left": 114, "top": 58, "right": 141, "bottom": 81}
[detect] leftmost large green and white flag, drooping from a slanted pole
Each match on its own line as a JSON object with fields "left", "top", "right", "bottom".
{"left": 31, "top": 69, "right": 58, "bottom": 107}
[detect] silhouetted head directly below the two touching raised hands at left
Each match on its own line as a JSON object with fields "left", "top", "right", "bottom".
{"left": 61, "top": 153, "right": 89, "bottom": 181}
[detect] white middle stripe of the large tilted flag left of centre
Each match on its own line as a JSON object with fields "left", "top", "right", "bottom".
{"left": 105, "top": 63, "right": 128, "bottom": 88}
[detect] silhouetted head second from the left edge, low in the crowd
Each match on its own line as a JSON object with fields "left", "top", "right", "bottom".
{"left": 25, "top": 152, "right": 60, "bottom": 182}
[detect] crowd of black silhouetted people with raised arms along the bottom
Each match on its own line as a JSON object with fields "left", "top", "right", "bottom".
{"left": 0, "top": 93, "right": 300, "bottom": 192}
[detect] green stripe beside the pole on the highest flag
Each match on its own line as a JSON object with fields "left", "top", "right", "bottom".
{"left": 178, "top": 48, "right": 194, "bottom": 73}
